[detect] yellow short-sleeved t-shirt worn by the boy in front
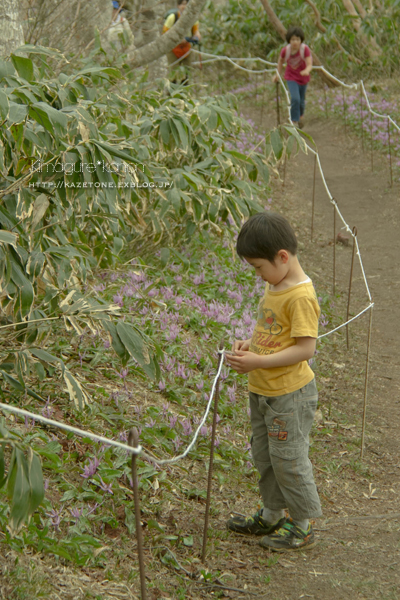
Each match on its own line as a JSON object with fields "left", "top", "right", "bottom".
{"left": 249, "top": 280, "right": 320, "bottom": 396}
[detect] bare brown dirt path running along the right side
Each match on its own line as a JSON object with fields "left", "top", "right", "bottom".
{"left": 222, "top": 105, "right": 400, "bottom": 600}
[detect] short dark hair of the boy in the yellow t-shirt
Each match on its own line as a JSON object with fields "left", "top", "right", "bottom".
{"left": 236, "top": 212, "right": 297, "bottom": 262}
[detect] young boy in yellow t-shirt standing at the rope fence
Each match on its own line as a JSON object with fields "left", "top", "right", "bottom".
{"left": 226, "top": 212, "right": 322, "bottom": 551}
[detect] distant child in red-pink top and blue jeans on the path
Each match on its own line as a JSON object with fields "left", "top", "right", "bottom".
{"left": 274, "top": 27, "right": 312, "bottom": 127}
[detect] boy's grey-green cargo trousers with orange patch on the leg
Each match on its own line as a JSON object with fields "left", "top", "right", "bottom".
{"left": 250, "top": 379, "right": 322, "bottom": 520}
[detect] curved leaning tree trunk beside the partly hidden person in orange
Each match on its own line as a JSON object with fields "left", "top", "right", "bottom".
{"left": 130, "top": 0, "right": 206, "bottom": 69}
